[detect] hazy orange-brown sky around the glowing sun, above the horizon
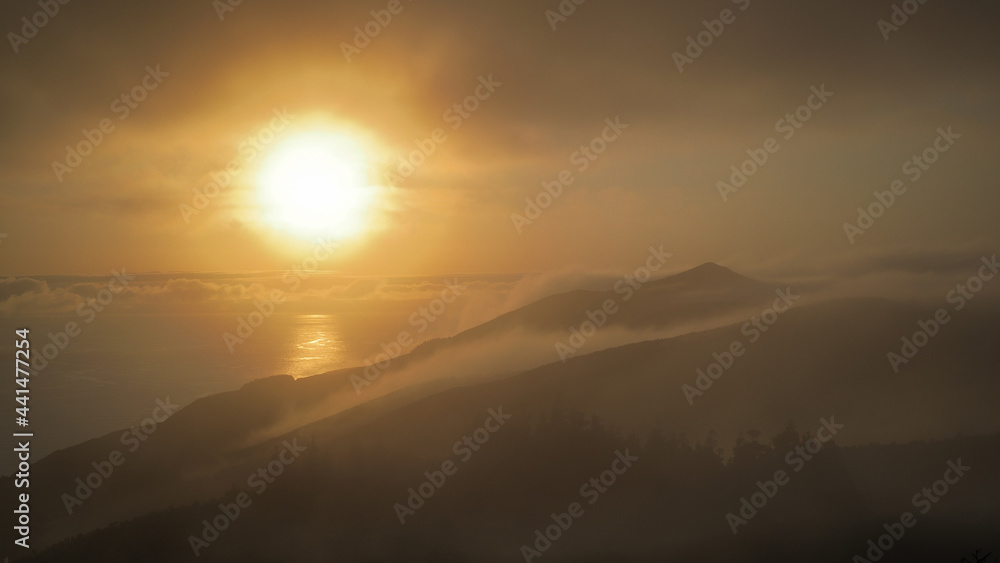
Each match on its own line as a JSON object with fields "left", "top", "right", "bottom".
{"left": 0, "top": 0, "right": 1000, "bottom": 275}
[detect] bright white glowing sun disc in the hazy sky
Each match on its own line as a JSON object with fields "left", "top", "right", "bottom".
{"left": 258, "top": 131, "right": 377, "bottom": 240}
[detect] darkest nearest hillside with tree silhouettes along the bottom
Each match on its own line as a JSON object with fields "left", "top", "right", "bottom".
{"left": 9, "top": 424, "right": 1000, "bottom": 563}
